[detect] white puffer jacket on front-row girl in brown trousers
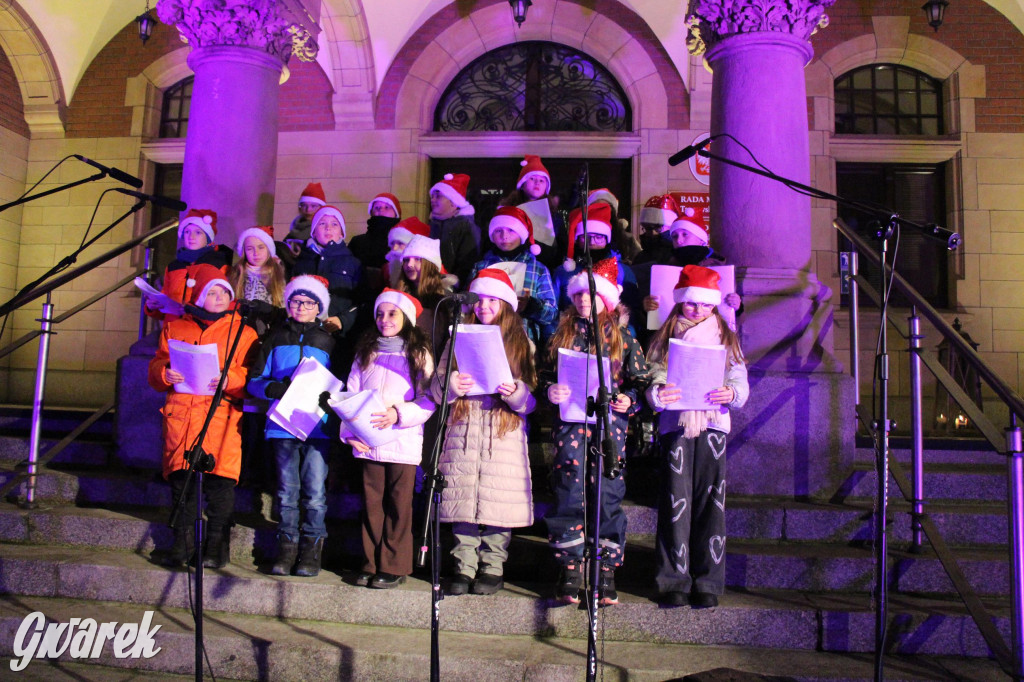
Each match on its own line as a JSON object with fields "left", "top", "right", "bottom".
{"left": 341, "top": 348, "right": 436, "bottom": 465}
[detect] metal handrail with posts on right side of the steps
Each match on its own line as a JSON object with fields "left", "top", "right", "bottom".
{"left": 833, "top": 219, "right": 1024, "bottom": 679}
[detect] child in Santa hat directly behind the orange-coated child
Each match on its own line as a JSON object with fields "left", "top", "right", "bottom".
{"left": 145, "top": 209, "right": 231, "bottom": 323}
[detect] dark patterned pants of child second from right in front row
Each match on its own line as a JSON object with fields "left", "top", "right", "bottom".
{"left": 544, "top": 414, "right": 627, "bottom": 568}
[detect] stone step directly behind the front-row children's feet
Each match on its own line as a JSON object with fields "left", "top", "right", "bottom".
{"left": 0, "top": 506, "right": 1010, "bottom": 595}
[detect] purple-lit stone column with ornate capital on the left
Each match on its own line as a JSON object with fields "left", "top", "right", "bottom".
{"left": 157, "top": 0, "right": 315, "bottom": 249}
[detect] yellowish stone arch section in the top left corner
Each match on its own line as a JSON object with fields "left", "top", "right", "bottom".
{"left": 0, "top": 0, "right": 67, "bottom": 137}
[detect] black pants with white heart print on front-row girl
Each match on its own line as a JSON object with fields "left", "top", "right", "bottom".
{"left": 655, "top": 429, "right": 725, "bottom": 595}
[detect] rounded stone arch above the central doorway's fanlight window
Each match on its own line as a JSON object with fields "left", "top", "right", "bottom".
{"left": 376, "top": 0, "right": 689, "bottom": 132}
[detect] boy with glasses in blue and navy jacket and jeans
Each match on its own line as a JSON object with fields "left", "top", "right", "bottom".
{"left": 249, "top": 274, "right": 334, "bottom": 578}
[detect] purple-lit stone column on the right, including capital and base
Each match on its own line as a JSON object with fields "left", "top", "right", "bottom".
{"left": 689, "top": 0, "right": 854, "bottom": 497}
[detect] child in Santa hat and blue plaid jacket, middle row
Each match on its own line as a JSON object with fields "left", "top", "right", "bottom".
{"left": 473, "top": 206, "right": 558, "bottom": 347}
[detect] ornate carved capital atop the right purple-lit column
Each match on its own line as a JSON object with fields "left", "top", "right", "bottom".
{"left": 686, "top": 0, "right": 836, "bottom": 54}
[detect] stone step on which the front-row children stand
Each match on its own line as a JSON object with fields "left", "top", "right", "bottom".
{"left": 0, "top": 546, "right": 1009, "bottom": 659}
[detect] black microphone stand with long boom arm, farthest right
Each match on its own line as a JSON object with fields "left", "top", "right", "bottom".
{"left": 686, "top": 139, "right": 961, "bottom": 682}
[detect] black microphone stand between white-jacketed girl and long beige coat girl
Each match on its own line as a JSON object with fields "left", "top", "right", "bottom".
{"left": 416, "top": 298, "right": 462, "bottom": 682}
